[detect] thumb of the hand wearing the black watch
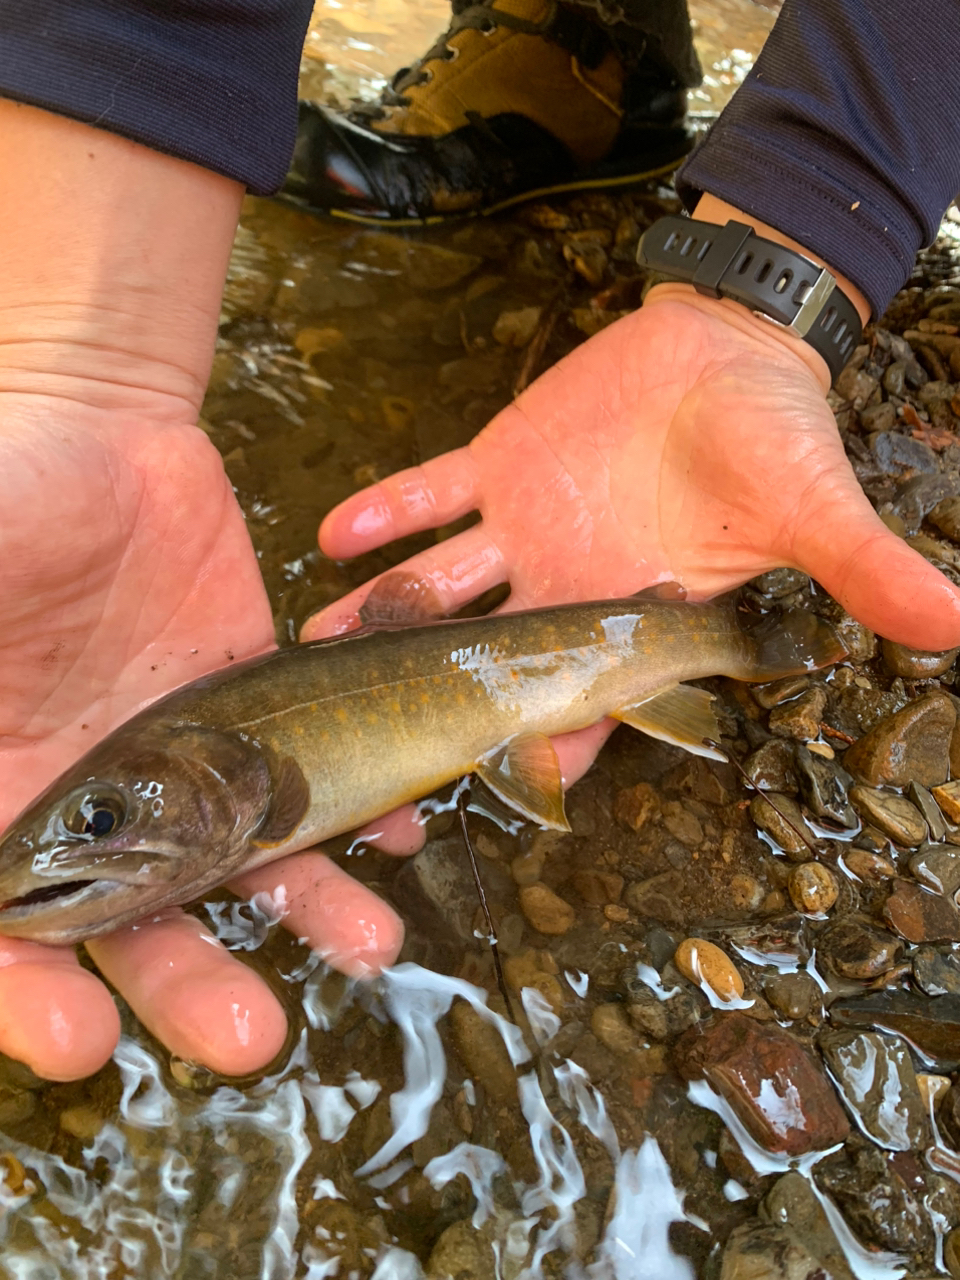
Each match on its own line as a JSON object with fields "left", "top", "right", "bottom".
{"left": 794, "top": 486, "right": 960, "bottom": 650}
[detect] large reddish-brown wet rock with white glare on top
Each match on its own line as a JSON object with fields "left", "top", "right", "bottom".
{"left": 673, "top": 1014, "right": 850, "bottom": 1156}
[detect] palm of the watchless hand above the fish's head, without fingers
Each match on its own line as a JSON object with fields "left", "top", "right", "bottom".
{"left": 0, "top": 408, "right": 273, "bottom": 827}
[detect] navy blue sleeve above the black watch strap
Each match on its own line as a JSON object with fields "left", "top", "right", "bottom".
{"left": 677, "top": 0, "right": 960, "bottom": 315}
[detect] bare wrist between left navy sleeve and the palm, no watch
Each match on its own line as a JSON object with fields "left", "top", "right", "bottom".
{"left": 0, "top": 100, "right": 243, "bottom": 421}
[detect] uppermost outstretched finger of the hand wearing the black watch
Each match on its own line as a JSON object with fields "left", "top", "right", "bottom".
{"left": 320, "top": 449, "right": 479, "bottom": 559}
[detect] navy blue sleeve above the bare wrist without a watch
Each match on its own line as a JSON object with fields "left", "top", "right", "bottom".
{"left": 0, "top": 0, "right": 312, "bottom": 195}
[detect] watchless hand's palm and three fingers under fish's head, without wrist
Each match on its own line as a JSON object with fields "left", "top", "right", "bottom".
{"left": 0, "top": 404, "right": 402, "bottom": 1079}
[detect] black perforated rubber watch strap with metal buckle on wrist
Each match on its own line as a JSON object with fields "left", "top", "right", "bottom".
{"left": 636, "top": 216, "right": 863, "bottom": 383}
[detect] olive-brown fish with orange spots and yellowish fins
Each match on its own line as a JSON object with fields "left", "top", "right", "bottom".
{"left": 0, "top": 586, "right": 845, "bottom": 946}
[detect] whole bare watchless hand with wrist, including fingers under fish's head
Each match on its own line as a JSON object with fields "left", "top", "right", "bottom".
{"left": 0, "top": 101, "right": 402, "bottom": 1080}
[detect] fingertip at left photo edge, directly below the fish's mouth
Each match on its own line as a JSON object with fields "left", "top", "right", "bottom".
{"left": 0, "top": 938, "right": 120, "bottom": 1080}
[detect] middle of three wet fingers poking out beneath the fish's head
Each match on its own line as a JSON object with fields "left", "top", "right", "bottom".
{"left": 87, "top": 911, "right": 287, "bottom": 1075}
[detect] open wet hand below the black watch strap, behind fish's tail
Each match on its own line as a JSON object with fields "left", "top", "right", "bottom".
{"left": 303, "top": 284, "right": 960, "bottom": 649}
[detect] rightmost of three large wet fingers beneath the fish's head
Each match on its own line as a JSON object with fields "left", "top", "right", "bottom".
{"left": 230, "top": 852, "right": 403, "bottom": 978}
